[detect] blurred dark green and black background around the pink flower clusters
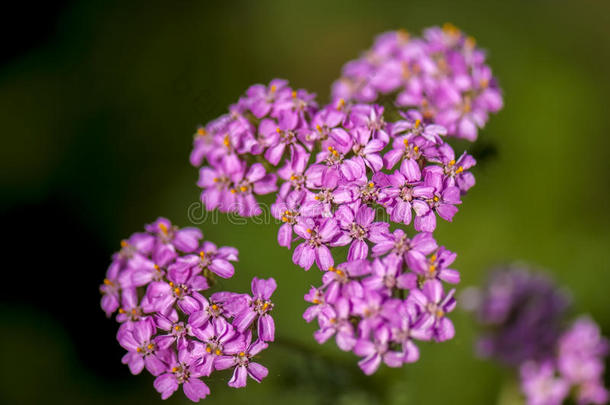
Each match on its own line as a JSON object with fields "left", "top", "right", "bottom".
{"left": 0, "top": 0, "right": 610, "bottom": 405}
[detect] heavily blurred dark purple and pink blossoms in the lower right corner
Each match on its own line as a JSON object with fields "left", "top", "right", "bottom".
{"left": 470, "top": 267, "right": 609, "bottom": 405}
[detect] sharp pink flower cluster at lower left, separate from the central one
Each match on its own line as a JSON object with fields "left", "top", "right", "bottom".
{"left": 100, "top": 218, "right": 276, "bottom": 402}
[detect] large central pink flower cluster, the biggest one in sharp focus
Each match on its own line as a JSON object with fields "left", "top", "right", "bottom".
{"left": 191, "top": 25, "right": 498, "bottom": 373}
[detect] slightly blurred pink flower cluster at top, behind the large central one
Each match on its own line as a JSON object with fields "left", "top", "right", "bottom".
{"left": 332, "top": 24, "right": 502, "bottom": 141}
